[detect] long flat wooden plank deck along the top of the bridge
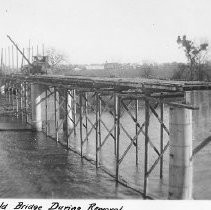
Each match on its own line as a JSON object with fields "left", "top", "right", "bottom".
{"left": 5, "top": 74, "right": 211, "bottom": 92}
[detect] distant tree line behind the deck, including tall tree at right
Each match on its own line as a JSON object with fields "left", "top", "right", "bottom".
{"left": 48, "top": 35, "right": 211, "bottom": 81}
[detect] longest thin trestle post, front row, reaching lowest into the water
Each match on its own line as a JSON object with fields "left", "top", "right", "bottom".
{"left": 144, "top": 98, "right": 149, "bottom": 197}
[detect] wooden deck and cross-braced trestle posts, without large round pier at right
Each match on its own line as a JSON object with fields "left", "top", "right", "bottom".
{"left": 1, "top": 75, "right": 211, "bottom": 197}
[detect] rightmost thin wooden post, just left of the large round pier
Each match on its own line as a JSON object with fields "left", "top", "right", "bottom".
{"left": 160, "top": 99, "right": 164, "bottom": 179}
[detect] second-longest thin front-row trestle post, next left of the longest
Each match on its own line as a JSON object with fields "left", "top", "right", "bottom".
{"left": 114, "top": 93, "right": 121, "bottom": 182}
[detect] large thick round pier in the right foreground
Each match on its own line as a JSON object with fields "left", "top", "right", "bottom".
{"left": 169, "top": 107, "right": 193, "bottom": 199}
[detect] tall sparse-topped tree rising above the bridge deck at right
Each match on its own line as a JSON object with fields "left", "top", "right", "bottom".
{"left": 177, "top": 35, "right": 208, "bottom": 80}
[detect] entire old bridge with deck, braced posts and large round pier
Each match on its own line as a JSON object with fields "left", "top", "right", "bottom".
{"left": 1, "top": 74, "right": 211, "bottom": 199}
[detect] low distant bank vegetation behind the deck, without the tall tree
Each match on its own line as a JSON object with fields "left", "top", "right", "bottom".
{"left": 49, "top": 62, "right": 211, "bottom": 81}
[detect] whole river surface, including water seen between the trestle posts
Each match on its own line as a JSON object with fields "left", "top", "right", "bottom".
{"left": 0, "top": 91, "right": 211, "bottom": 199}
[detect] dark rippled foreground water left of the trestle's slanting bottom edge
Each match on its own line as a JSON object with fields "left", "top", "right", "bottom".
{"left": 0, "top": 122, "right": 141, "bottom": 199}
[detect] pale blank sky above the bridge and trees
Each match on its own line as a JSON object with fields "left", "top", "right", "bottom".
{"left": 0, "top": 0, "right": 211, "bottom": 64}
